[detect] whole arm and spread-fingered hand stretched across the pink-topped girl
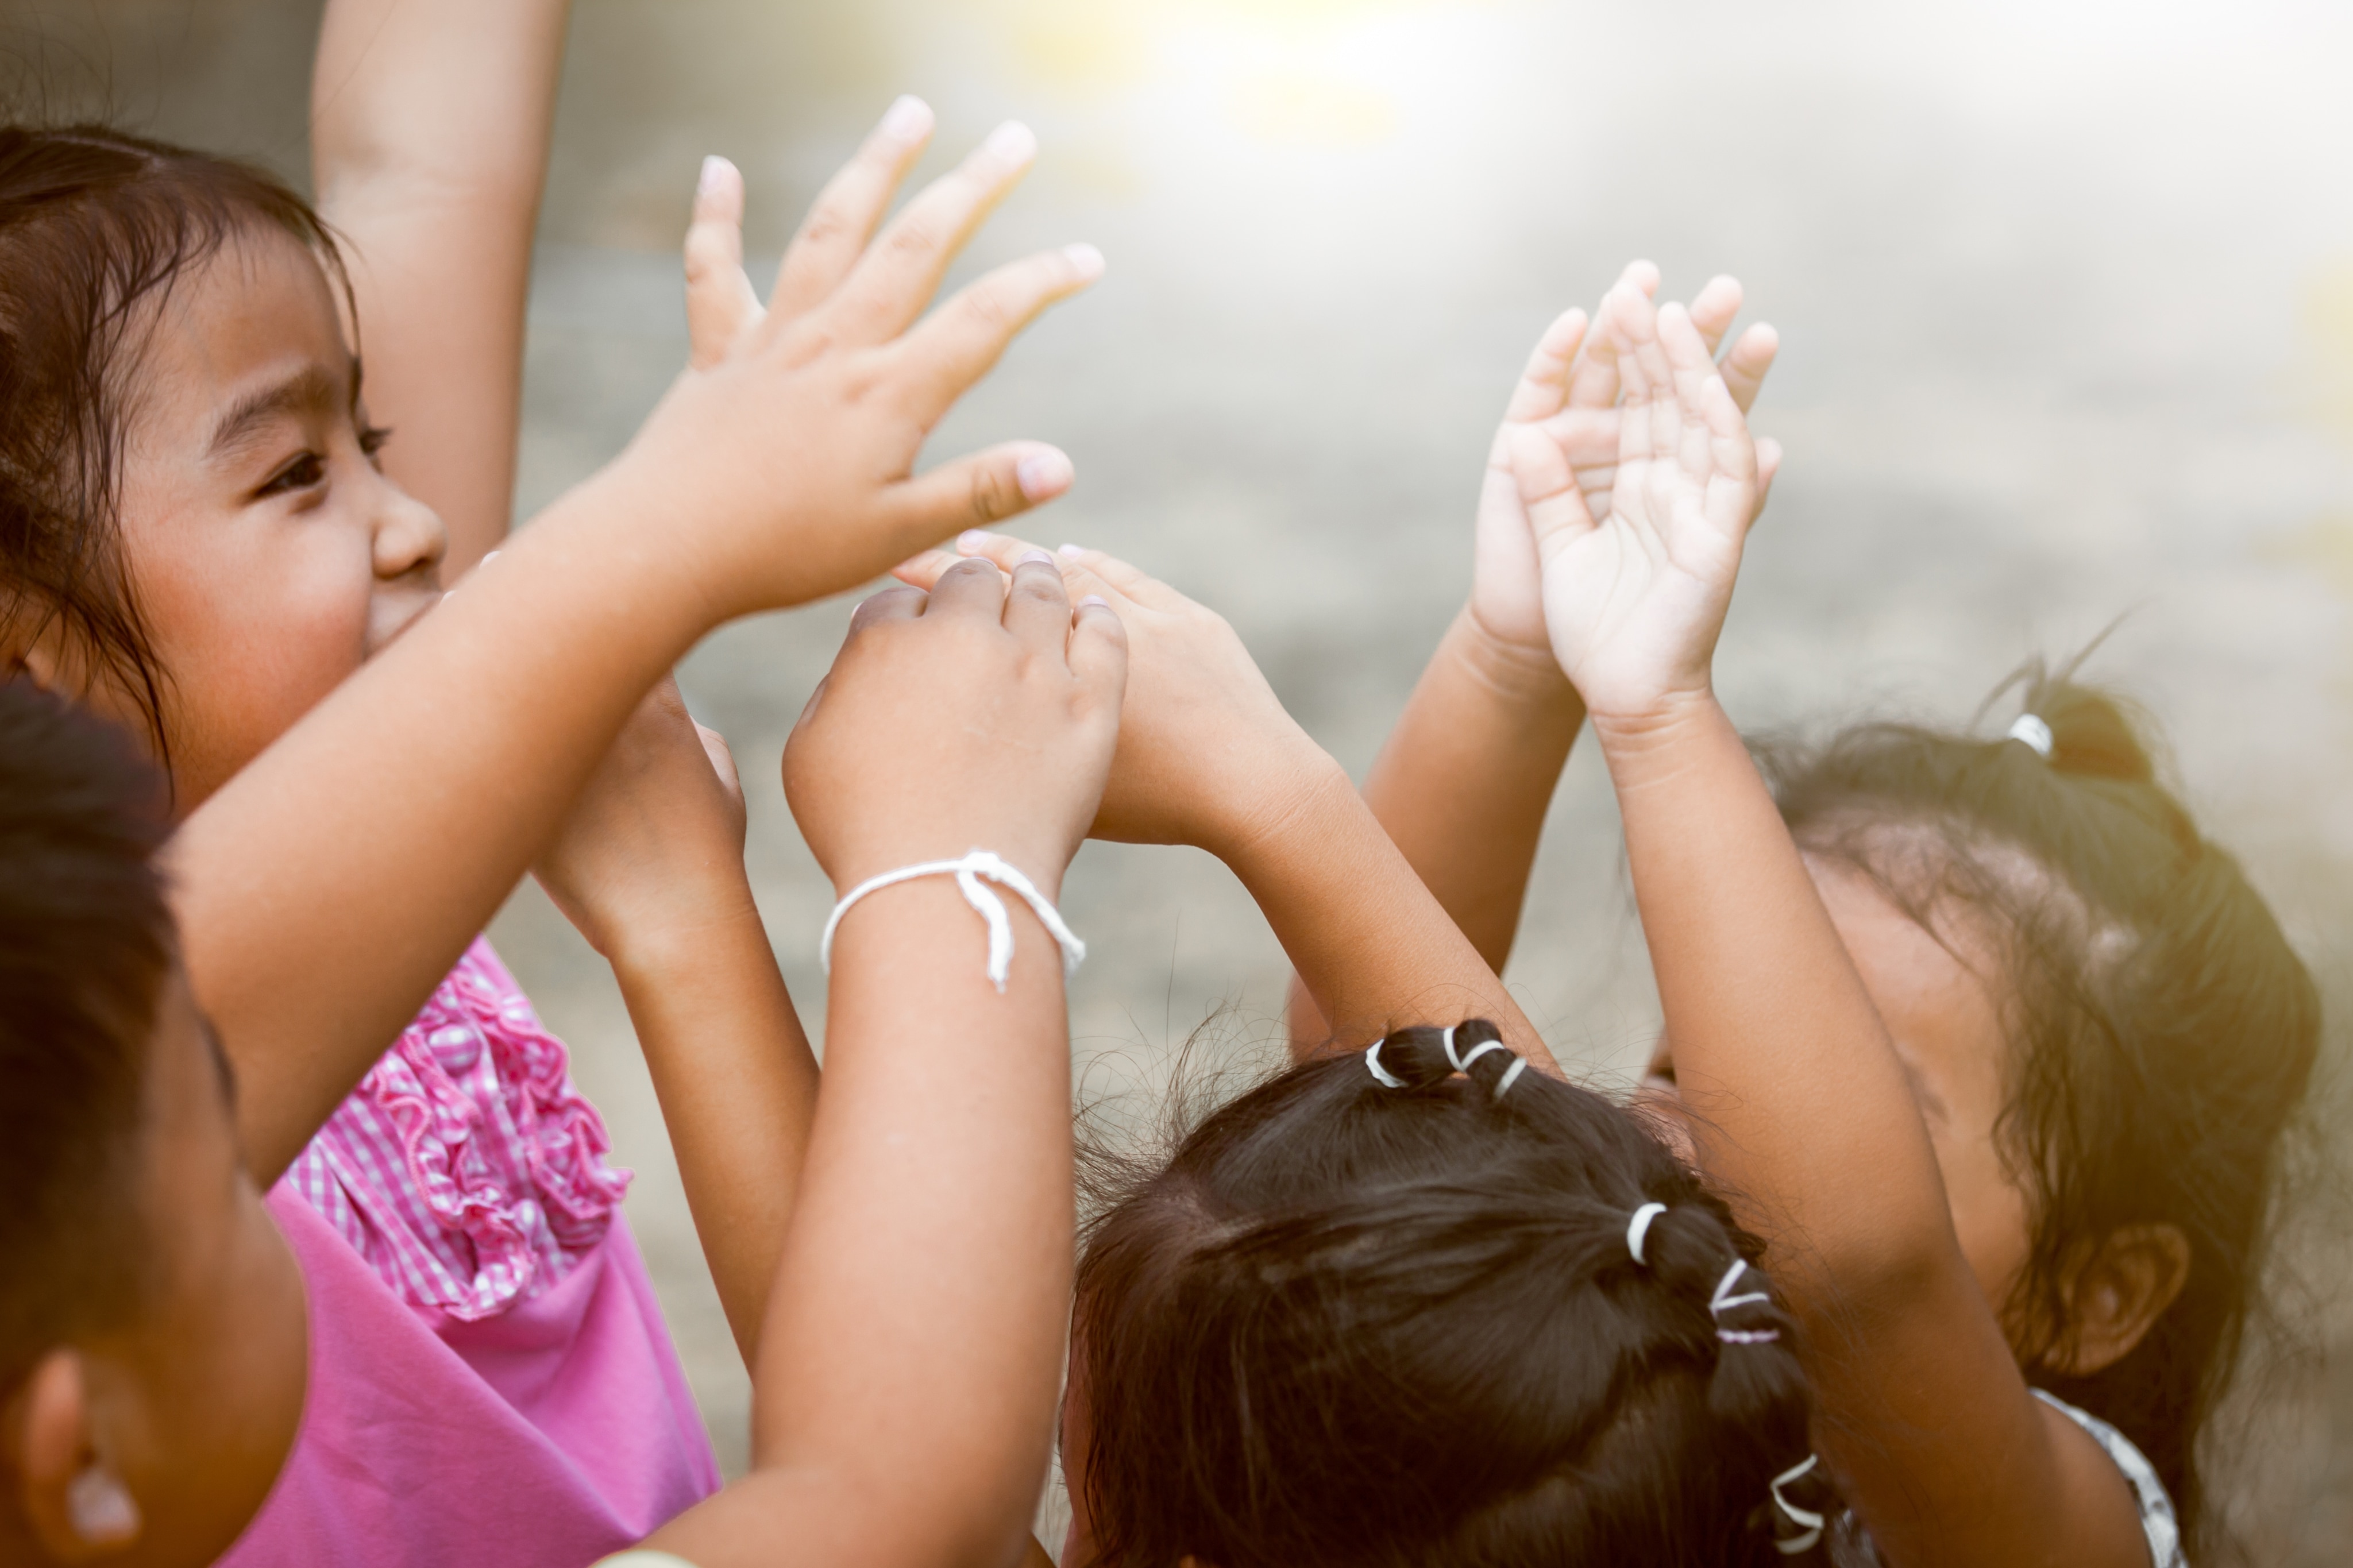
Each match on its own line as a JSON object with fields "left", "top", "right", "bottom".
{"left": 174, "top": 113, "right": 1099, "bottom": 1183}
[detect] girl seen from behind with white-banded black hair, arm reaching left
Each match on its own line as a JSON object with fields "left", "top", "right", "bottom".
{"left": 901, "top": 534, "right": 1826, "bottom": 1568}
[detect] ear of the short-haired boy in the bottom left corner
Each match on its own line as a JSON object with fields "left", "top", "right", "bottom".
{"left": 0, "top": 1349, "right": 139, "bottom": 1563}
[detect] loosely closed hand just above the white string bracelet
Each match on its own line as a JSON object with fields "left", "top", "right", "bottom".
{"left": 784, "top": 559, "right": 1127, "bottom": 898}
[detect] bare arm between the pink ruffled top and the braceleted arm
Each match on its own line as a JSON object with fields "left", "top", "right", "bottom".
{"left": 537, "top": 682, "right": 816, "bottom": 1366}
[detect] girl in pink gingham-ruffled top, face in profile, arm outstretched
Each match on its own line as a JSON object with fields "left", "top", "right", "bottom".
{"left": 0, "top": 17, "right": 1097, "bottom": 1561}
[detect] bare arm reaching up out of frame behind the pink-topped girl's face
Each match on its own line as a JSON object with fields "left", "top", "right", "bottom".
{"left": 311, "top": 0, "right": 572, "bottom": 581}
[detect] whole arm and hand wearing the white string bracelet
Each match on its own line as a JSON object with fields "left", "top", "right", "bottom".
{"left": 649, "top": 562, "right": 1123, "bottom": 1568}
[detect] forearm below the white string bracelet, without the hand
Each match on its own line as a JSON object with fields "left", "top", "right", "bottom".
{"left": 647, "top": 877, "right": 1073, "bottom": 1568}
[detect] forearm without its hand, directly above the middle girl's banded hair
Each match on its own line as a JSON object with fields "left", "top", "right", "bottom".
{"left": 1221, "top": 759, "right": 1558, "bottom": 1072}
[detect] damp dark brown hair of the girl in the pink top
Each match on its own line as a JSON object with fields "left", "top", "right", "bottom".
{"left": 0, "top": 125, "right": 348, "bottom": 757}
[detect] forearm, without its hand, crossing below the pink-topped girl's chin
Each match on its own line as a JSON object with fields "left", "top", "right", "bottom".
{"left": 169, "top": 473, "right": 715, "bottom": 1185}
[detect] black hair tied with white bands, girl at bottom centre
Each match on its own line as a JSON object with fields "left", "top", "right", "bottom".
{"left": 1071, "top": 1022, "right": 1829, "bottom": 1568}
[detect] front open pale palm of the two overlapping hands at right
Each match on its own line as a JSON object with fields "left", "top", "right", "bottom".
{"left": 1511, "top": 284, "right": 1760, "bottom": 724}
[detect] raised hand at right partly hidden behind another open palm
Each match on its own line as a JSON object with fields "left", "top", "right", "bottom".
{"left": 1471, "top": 261, "right": 1781, "bottom": 651}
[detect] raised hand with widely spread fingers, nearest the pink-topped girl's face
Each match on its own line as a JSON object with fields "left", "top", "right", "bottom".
{"left": 616, "top": 101, "right": 1104, "bottom": 618}
